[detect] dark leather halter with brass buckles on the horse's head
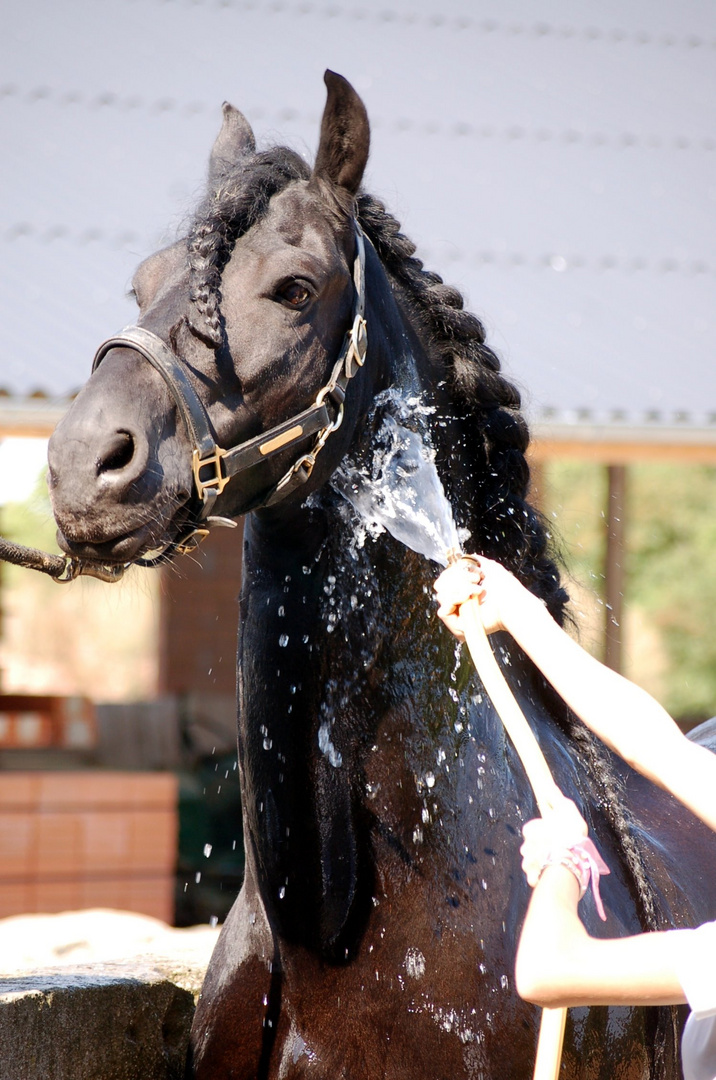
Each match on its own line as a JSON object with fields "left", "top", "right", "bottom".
{"left": 92, "top": 221, "right": 368, "bottom": 562}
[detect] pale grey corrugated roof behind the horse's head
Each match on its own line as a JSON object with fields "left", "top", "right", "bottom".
{"left": 0, "top": 0, "right": 716, "bottom": 428}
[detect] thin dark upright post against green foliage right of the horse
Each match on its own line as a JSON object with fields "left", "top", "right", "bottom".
{"left": 604, "top": 464, "right": 626, "bottom": 672}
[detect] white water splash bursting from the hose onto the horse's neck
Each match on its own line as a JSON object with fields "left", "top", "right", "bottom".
{"left": 333, "top": 414, "right": 469, "bottom": 566}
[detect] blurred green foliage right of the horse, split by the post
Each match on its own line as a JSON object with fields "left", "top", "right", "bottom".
{"left": 544, "top": 461, "right": 716, "bottom": 719}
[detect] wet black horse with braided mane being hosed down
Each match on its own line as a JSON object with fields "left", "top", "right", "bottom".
{"left": 50, "top": 72, "right": 716, "bottom": 1080}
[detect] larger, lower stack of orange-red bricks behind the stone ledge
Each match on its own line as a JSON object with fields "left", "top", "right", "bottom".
{"left": 0, "top": 771, "right": 177, "bottom": 922}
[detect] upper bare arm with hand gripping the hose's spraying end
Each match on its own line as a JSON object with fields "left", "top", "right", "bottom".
{"left": 435, "top": 556, "right": 716, "bottom": 829}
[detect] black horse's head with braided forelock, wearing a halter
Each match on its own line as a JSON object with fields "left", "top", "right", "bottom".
{"left": 50, "top": 72, "right": 378, "bottom": 563}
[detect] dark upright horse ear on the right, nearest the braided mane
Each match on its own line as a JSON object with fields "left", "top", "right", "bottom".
{"left": 313, "top": 71, "right": 370, "bottom": 195}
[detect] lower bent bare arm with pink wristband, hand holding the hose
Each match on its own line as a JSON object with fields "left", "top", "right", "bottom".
{"left": 515, "top": 812, "right": 693, "bottom": 1008}
